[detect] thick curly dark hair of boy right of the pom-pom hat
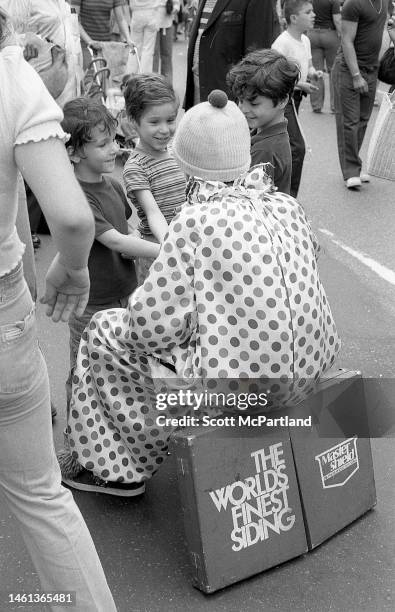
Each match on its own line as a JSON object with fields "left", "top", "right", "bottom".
{"left": 226, "top": 49, "right": 300, "bottom": 106}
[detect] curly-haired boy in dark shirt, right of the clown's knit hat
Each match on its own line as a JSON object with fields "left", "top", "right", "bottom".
{"left": 227, "top": 49, "right": 299, "bottom": 194}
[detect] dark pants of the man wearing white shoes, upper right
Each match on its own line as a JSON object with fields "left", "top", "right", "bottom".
{"left": 332, "top": 59, "right": 377, "bottom": 181}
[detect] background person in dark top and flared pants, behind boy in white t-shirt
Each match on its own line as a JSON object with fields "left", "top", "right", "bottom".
{"left": 307, "top": 0, "right": 341, "bottom": 113}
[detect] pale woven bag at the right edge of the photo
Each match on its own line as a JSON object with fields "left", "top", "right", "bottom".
{"left": 367, "top": 92, "right": 395, "bottom": 181}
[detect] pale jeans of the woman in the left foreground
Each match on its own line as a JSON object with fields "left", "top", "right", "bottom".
{"left": 0, "top": 264, "right": 116, "bottom": 612}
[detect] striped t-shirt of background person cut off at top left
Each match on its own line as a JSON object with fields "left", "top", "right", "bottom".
{"left": 71, "top": 0, "right": 126, "bottom": 41}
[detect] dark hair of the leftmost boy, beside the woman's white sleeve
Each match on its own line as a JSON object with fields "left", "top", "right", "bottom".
{"left": 61, "top": 96, "right": 118, "bottom": 151}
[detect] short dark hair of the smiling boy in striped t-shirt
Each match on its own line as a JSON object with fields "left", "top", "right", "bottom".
{"left": 123, "top": 74, "right": 179, "bottom": 123}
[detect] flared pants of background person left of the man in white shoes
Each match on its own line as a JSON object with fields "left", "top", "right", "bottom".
{"left": 308, "top": 28, "right": 340, "bottom": 110}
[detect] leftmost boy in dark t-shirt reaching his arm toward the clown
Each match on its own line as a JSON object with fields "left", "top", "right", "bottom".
{"left": 62, "top": 98, "right": 159, "bottom": 407}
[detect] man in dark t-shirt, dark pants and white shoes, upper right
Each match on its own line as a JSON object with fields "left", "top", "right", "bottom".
{"left": 332, "top": 0, "right": 388, "bottom": 189}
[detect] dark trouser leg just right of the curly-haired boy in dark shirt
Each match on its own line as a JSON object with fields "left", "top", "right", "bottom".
{"left": 284, "top": 91, "right": 306, "bottom": 198}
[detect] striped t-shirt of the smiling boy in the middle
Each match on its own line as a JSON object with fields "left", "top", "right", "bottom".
{"left": 123, "top": 151, "right": 186, "bottom": 237}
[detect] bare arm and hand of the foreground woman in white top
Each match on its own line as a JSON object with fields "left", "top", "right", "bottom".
{"left": 15, "top": 138, "right": 94, "bottom": 321}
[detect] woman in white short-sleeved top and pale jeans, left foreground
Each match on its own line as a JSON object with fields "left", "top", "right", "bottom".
{"left": 0, "top": 8, "right": 115, "bottom": 612}
